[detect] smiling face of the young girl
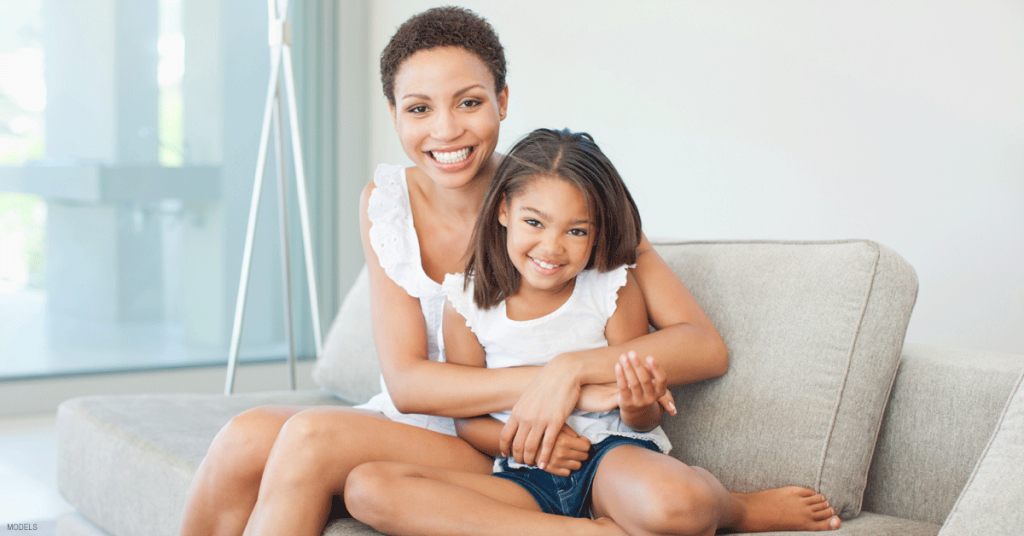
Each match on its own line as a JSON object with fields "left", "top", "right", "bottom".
{"left": 498, "top": 176, "right": 595, "bottom": 293}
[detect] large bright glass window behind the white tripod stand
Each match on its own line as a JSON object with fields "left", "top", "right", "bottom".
{"left": 0, "top": 0, "right": 337, "bottom": 379}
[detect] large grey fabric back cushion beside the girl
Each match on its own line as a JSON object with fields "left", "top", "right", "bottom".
{"left": 656, "top": 241, "right": 918, "bottom": 519}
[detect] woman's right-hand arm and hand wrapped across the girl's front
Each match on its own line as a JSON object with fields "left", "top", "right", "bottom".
{"left": 502, "top": 237, "right": 729, "bottom": 463}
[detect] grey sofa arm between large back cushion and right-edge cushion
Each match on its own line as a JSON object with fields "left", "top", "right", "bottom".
{"left": 864, "top": 344, "right": 1024, "bottom": 524}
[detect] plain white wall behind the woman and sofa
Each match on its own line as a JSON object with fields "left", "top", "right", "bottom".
{"left": 368, "top": 0, "right": 1024, "bottom": 354}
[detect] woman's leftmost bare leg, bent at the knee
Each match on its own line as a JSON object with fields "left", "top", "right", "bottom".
{"left": 180, "top": 406, "right": 306, "bottom": 536}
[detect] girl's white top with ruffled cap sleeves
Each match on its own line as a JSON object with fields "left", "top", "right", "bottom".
{"left": 441, "top": 266, "right": 672, "bottom": 470}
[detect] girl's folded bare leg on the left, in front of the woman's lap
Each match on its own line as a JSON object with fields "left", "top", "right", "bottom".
{"left": 345, "top": 462, "right": 625, "bottom": 536}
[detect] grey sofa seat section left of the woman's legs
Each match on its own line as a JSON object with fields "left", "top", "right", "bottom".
{"left": 56, "top": 391, "right": 342, "bottom": 536}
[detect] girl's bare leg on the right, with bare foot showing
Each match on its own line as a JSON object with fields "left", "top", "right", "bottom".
{"left": 592, "top": 446, "right": 840, "bottom": 536}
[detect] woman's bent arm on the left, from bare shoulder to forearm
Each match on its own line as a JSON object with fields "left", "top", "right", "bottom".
{"left": 359, "top": 182, "right": 536, "bottom": 418}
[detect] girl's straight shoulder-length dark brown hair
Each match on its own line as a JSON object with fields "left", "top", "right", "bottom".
{"left": 466, "top": 128, "right": 641, "bottom": 308}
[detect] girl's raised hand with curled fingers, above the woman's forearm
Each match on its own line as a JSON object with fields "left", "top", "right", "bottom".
{"left": 615, "top": 352, "right": 675, "bottom": 429}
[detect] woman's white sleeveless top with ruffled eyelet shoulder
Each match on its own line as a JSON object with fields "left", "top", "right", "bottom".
{"left": 357, "top": 164, "right": 455, "bottom": 436}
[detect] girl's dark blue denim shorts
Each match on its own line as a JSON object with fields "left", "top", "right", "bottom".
{"left": 495, "top": 436, "right": 662, "bottom": 518}
